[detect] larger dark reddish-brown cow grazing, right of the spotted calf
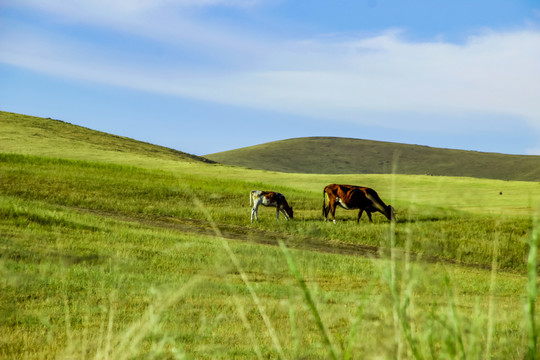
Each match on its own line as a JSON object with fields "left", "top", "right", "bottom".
{"left": 323, "top": 184, "right": 395, "bottom": 223}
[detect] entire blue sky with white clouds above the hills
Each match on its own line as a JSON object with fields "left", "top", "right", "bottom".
{"left": 0, "top": 0, "right": 540, "bottom": 155}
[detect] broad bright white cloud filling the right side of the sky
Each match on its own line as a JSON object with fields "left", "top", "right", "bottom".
{"left": 155, "top": 31, "right": 540, "bottom": 128}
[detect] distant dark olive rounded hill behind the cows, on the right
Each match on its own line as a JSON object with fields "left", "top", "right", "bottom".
{"left": 205, "top": 137, "right": 540, "bottom": 181}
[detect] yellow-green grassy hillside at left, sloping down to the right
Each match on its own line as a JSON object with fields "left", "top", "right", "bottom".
{"left": 0, "top": 111, "right": 211, "bottom": 165}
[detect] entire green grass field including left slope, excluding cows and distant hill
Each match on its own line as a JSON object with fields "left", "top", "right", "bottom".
{"left": 0, "top": 113, "right": 540, "bottom": 359}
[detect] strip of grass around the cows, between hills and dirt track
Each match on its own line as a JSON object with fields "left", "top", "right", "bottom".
{"left": 0, "top": 155, "right": 538, "bottom": 270}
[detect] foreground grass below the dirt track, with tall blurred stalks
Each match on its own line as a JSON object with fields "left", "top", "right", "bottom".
{"left": 0, "top": 191, "right": 527, "bottom": 359}
